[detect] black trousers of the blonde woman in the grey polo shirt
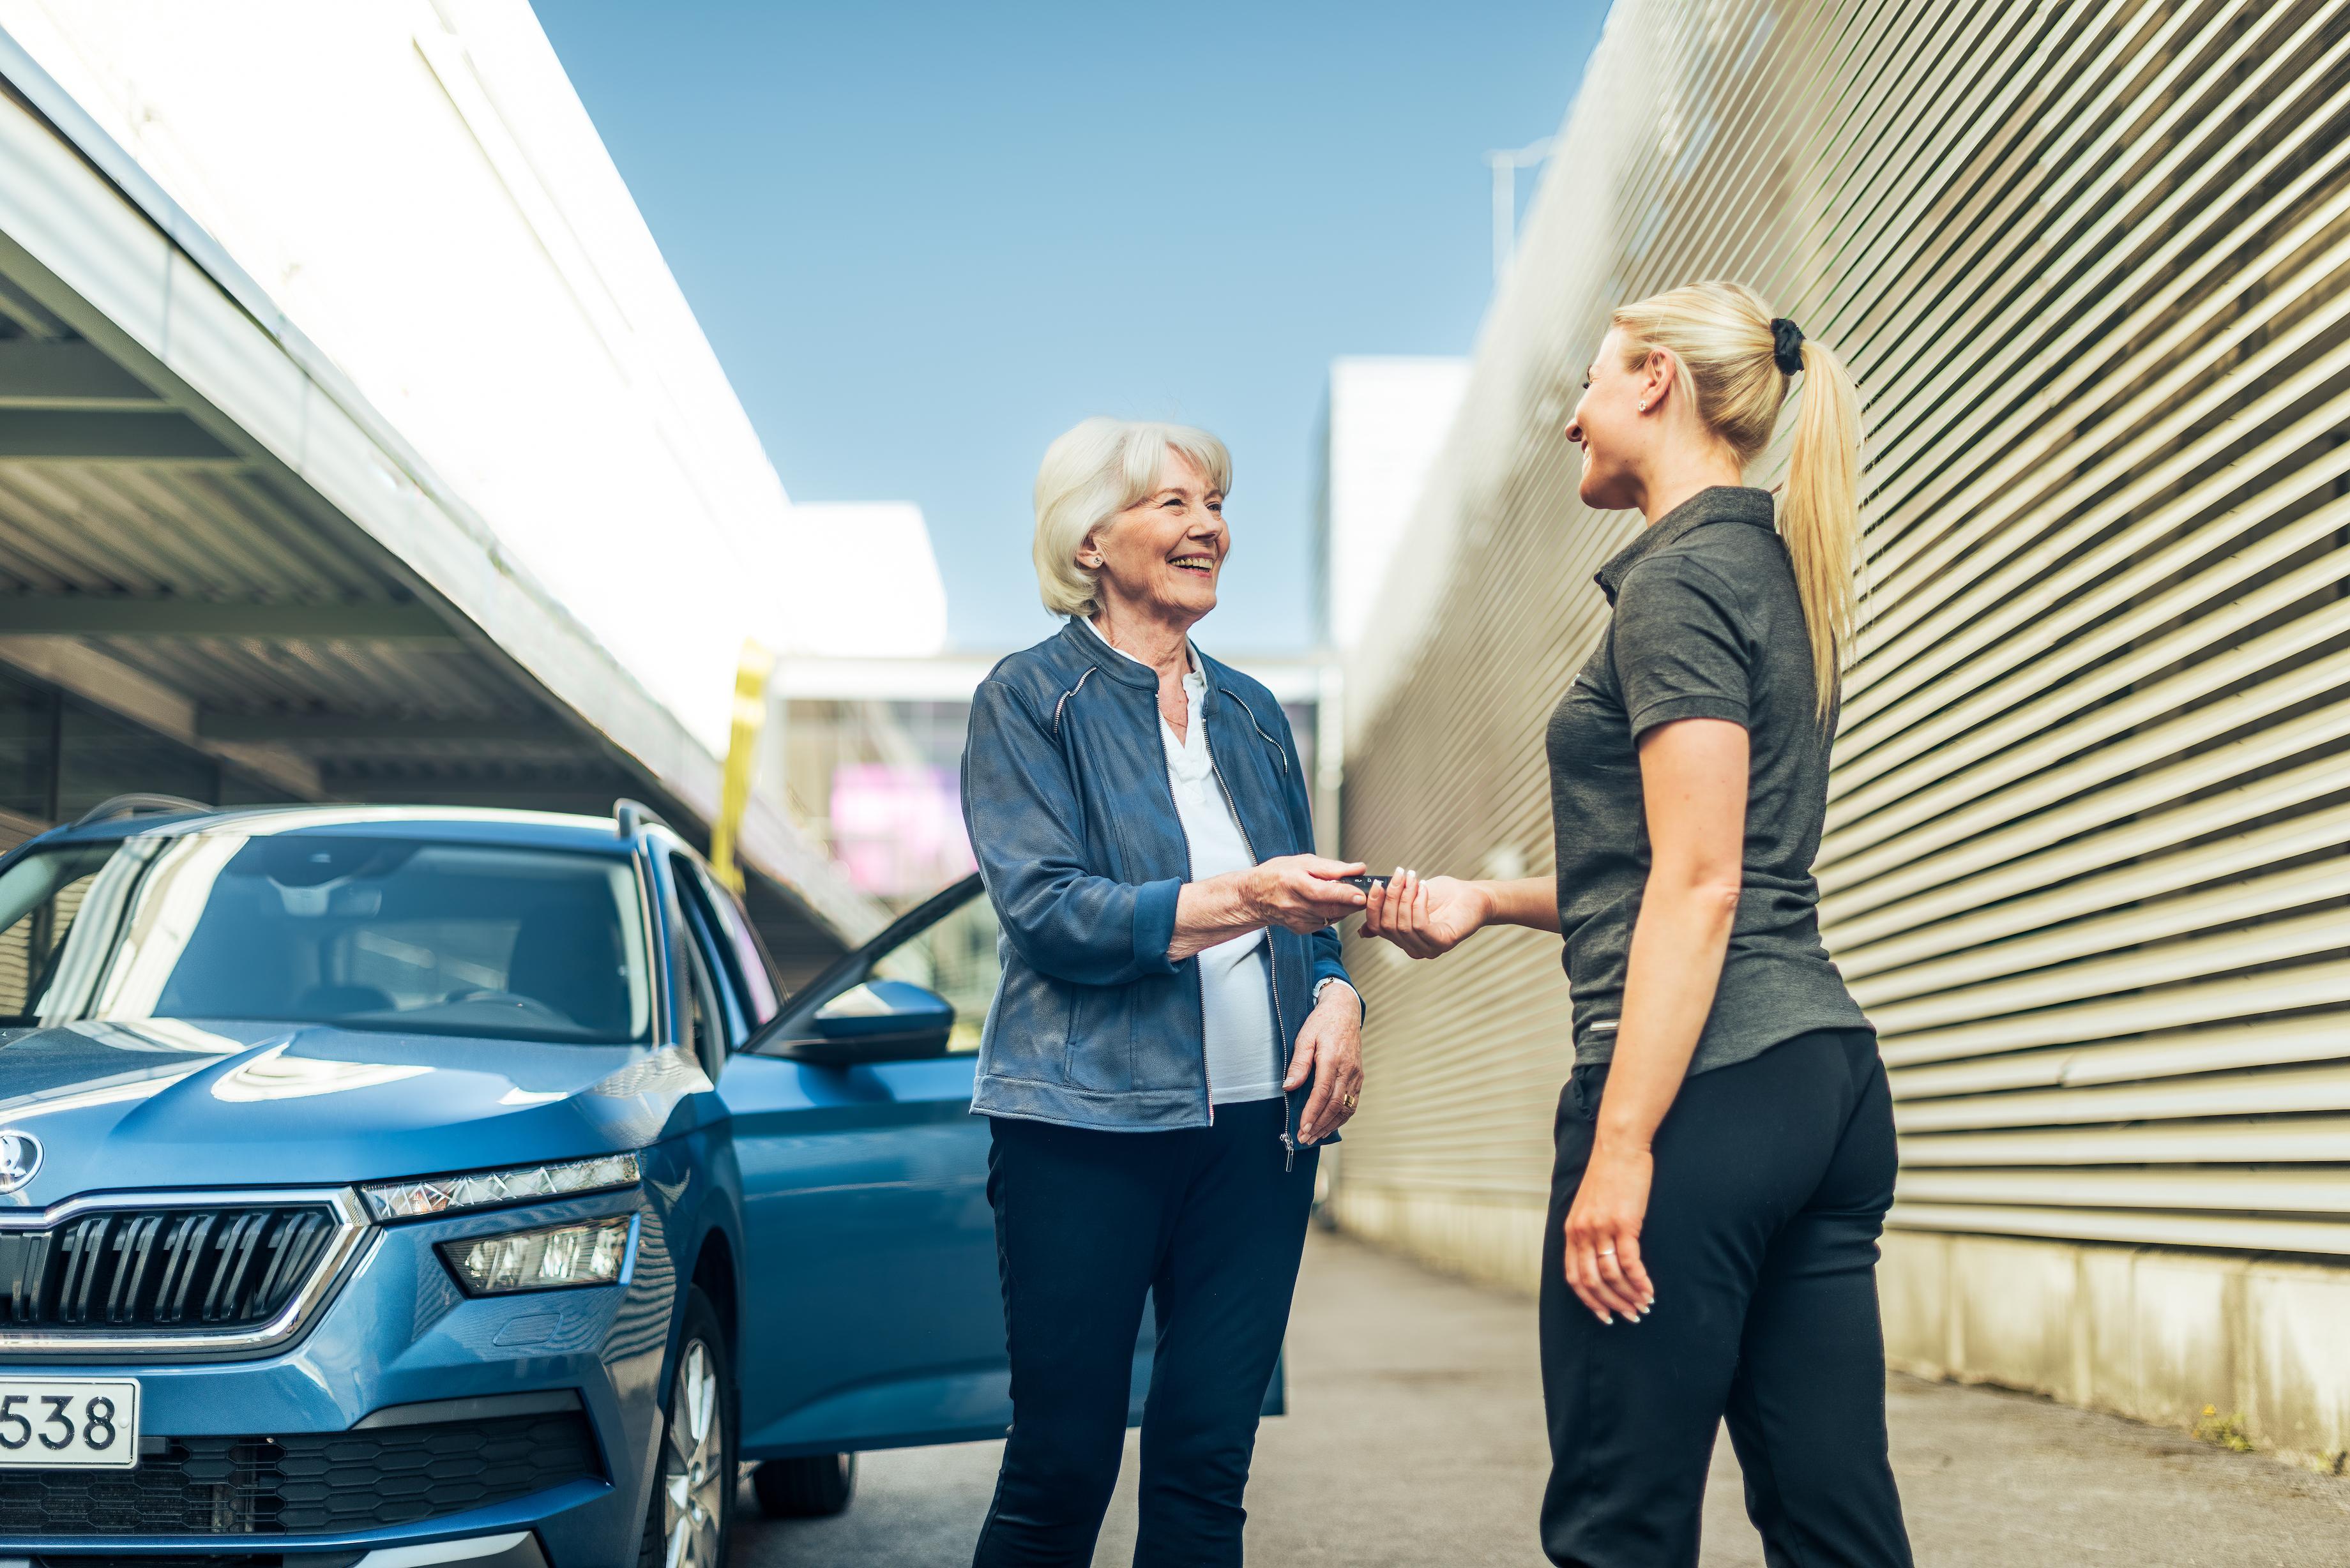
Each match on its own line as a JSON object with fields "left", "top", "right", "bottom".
{"left": 1542, "top": 1032, "right": 1911, "bottom": 1568}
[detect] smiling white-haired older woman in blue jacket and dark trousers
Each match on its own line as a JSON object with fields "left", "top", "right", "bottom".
{"left": 964, "top": 418, "right": 1363, "bottom": 1568}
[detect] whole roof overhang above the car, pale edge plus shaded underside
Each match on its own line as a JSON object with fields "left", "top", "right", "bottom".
{"left": 0, "top": 33, "right": 881, "bottom": 950}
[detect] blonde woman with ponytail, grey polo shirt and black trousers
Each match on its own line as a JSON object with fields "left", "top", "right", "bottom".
{"left": 1365, "top": 282, "right": 1911, "bottom": 1568}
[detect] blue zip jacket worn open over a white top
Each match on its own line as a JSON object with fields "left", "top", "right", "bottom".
{"left": 964, "top": 621, "right": 1347, "bottom": 1152}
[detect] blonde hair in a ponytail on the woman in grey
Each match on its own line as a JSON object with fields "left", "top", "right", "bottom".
{"left": 1610, "top": 282, "right": 1861, "bottom": 724}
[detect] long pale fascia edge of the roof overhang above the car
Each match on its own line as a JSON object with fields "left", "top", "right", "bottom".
{"left": 0, "top": 28, "right": 886, "bottom": 943}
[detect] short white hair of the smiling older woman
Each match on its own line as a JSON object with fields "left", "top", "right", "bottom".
{"left": 1036, "top": 416, "right": 1231, "bottom": 618}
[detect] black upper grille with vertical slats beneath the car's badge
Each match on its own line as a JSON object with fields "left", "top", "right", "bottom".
{"left": 0, "top": 1203, "right": 341, "bottom": 1333}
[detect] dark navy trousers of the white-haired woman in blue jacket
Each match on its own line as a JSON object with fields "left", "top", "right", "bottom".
{"left": 973, "top": 1100, "right": 1318, "bottom": 1568}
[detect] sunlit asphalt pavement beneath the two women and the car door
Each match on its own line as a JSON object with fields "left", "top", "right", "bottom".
{"left": 733, "top": 1232, "right": 2350, "bottom": 1568}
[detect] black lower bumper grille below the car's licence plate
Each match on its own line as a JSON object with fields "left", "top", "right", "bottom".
{"left": 0, "top": 1410, "right": 604, "bottom": 1537}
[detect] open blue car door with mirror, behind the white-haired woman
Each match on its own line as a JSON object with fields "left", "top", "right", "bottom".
{"left": 719, "top": 877, "right": 1010, "bottom": 1460}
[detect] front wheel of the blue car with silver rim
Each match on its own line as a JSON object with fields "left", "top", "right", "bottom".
{"left": 637, "top": 1286, "right": 736, "bottom": 1568}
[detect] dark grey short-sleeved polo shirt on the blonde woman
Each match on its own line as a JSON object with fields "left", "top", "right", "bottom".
{"left": 1546, "top": 486, "right": 1869, "bottom": 1072}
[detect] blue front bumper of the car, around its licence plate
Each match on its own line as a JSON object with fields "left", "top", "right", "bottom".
{"left": 0, "top": 1189, "right": 677, "bottom": 1568}
